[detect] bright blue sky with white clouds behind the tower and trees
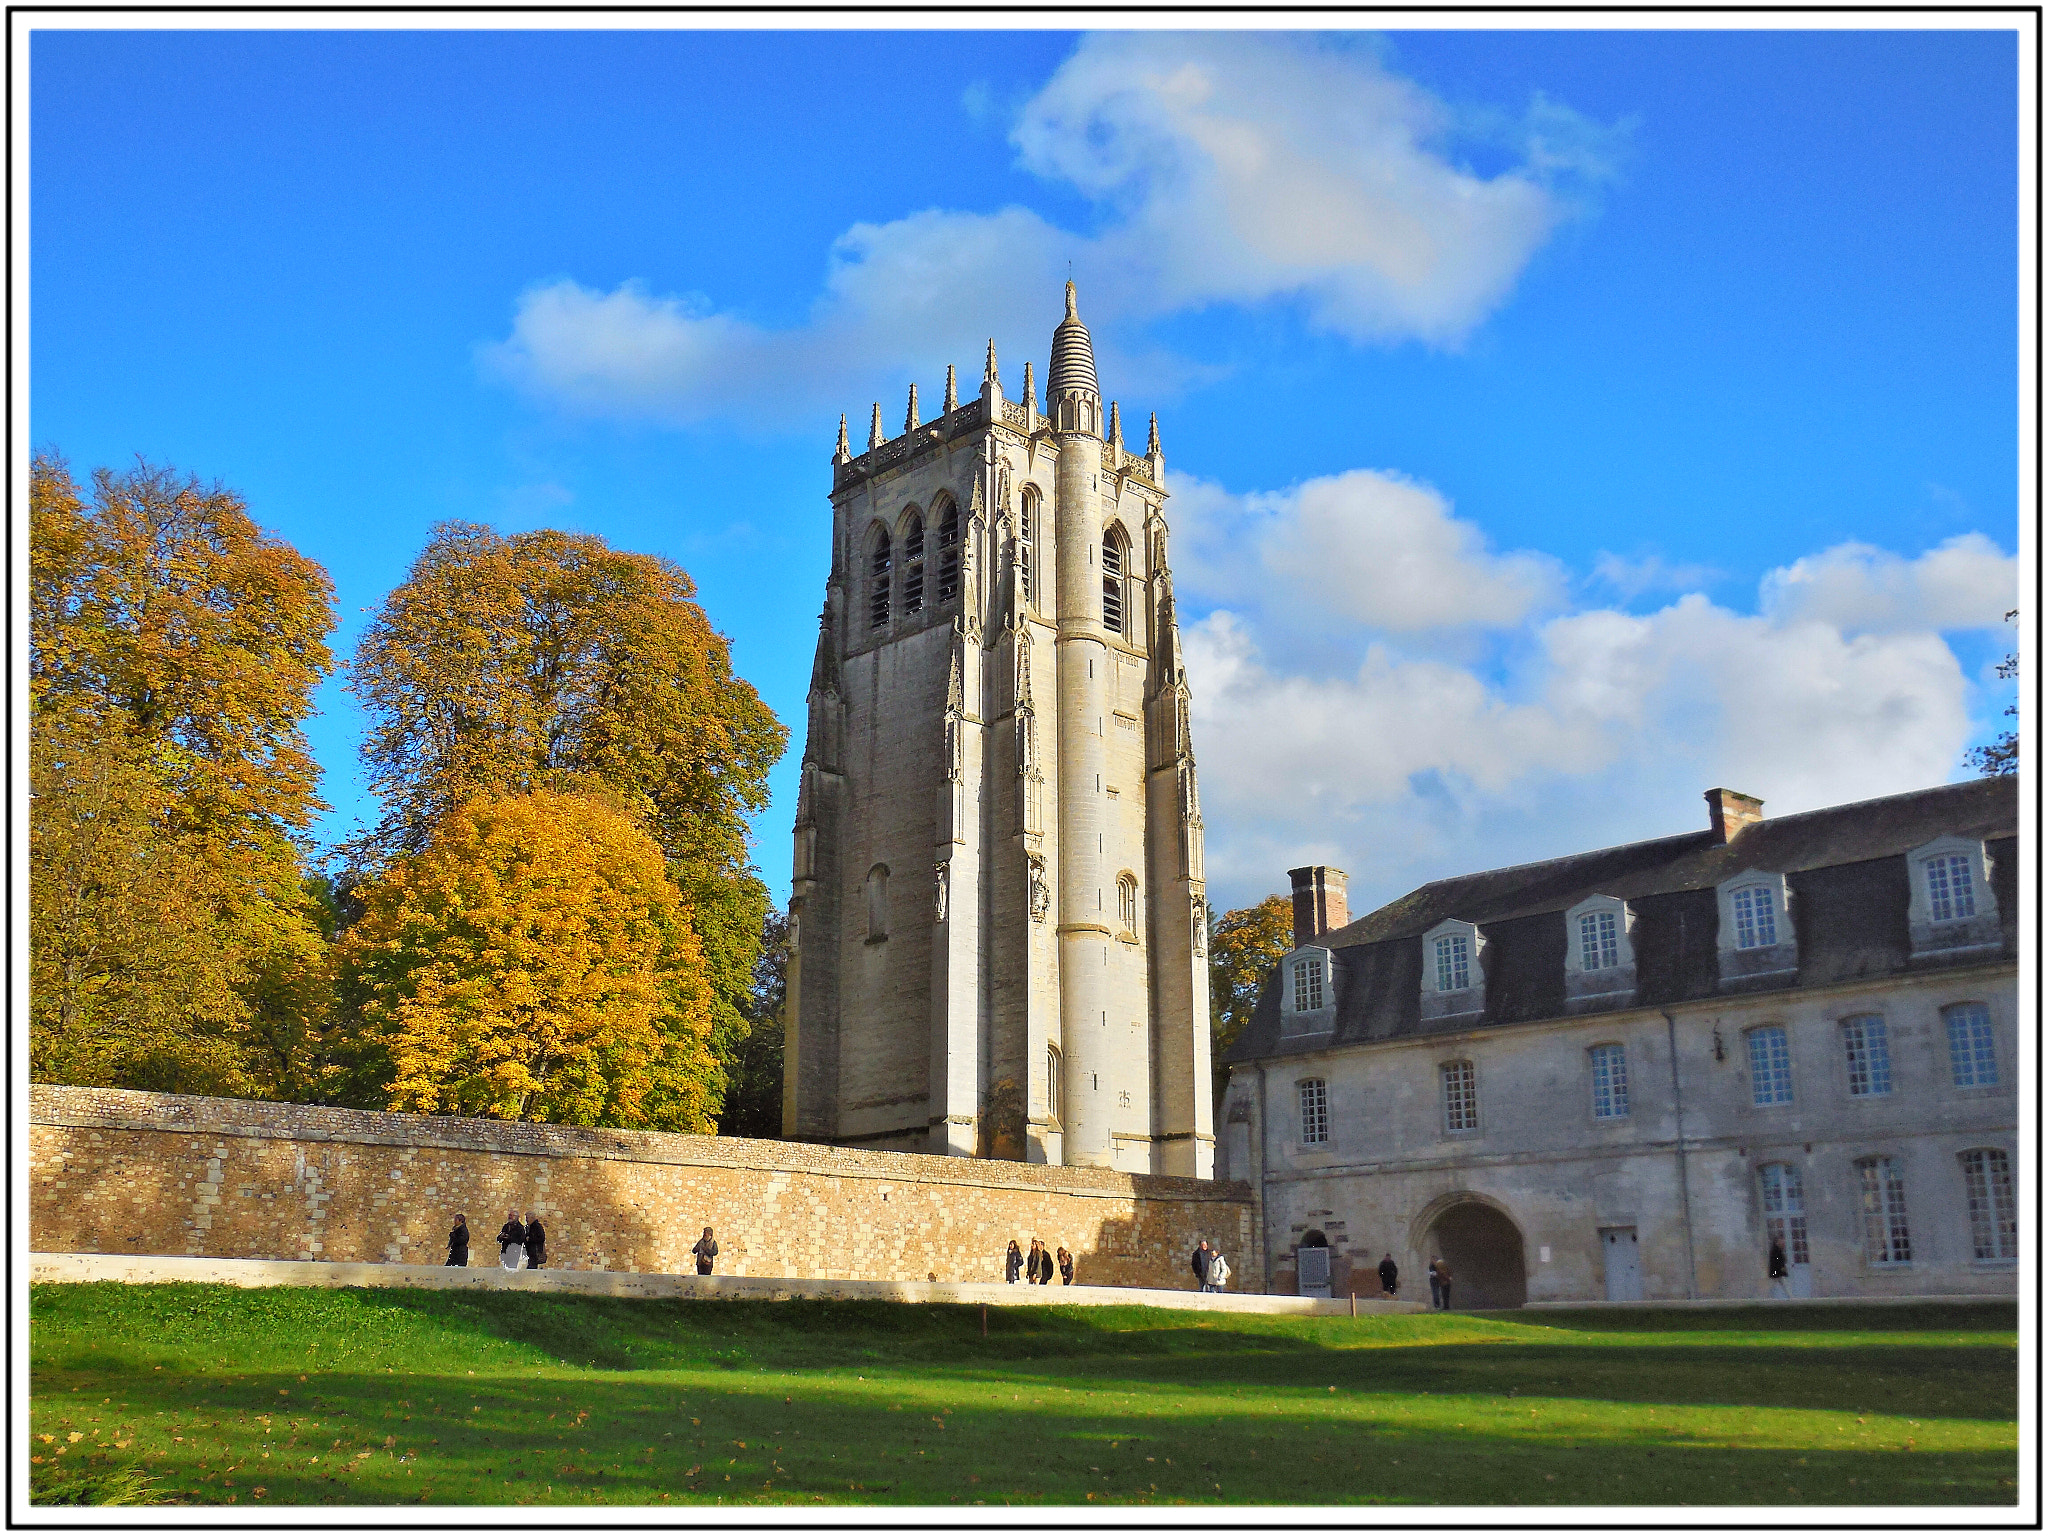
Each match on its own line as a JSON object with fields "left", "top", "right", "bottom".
{"left": 31, "top": 31, "right": 2032, "bottom": 905}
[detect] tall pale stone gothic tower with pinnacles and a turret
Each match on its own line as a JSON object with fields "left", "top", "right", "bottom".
{"left": 782, "top": 283, "right": 1214, "bottom": 1178}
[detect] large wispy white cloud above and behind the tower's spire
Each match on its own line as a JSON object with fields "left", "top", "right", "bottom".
{"left": 483, "top": 33, "right": 1612, "bottom": 430}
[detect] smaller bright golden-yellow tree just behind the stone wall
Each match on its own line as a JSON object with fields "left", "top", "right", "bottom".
{"left": 340, "top": 788, "right": 725, "bottom": 1130}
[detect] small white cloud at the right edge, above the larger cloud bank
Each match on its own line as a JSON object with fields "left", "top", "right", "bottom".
{"left": 1763, "top": 532, "right": 2019, "bottom": 635}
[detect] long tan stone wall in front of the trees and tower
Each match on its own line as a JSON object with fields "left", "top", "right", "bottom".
{"left": 29, "top": 1085, "right": 1253, "bottom": 1288}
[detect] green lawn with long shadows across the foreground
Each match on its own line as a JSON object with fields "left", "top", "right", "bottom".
{"left": 31, "top": 1284, "right": 2017, "bottom": 1507}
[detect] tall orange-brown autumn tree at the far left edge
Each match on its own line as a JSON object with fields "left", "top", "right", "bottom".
{"left": 29, "top": 455, "right": 334, "bottom": 1096}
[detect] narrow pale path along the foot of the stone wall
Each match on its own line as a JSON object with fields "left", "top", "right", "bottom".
{"left": 29, "top": 1253, "right": 1423, "bottom": 1317}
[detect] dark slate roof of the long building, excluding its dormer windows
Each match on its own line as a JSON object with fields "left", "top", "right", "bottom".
{"left": 1223, "top": 778, "right": 2019, "bottom": 1063}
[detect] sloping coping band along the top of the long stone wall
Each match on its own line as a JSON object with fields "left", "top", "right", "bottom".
{"left": 29, "top": 1083, "right": 1251, "bottom": 1204}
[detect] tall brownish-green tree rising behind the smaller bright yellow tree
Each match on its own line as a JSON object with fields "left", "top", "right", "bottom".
{"left": 350, "top": 522, "right": 788, "bottom": 1114}
